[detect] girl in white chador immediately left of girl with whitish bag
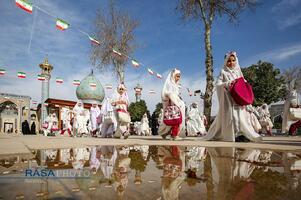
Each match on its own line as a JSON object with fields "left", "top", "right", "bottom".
{"left": 100, "top": 98, "right": 117, "bottom": 138}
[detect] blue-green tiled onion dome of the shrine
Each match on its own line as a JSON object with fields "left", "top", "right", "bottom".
{"left": 76, "top": 72, "right": 105, "bottom": 104}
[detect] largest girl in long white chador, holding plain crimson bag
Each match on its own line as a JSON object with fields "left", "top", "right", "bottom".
{"left": 204, "top": 52, "right": 261, "bottom": 142}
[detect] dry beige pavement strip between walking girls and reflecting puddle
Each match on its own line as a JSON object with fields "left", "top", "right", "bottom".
{"left": 0, "top": 134, "right": 301, "bottom": 155}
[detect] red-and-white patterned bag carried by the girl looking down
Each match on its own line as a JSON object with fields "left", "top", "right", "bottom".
{"left": 163, "top": 103, "right": 182, "bottom": 126}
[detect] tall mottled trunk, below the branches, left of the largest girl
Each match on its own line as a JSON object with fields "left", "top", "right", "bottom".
{"left": 204, "top": 24, "right": 214, "bottom": 125}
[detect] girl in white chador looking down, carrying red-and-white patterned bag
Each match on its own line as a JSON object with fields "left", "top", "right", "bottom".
{"left": 158, "top": 69, "right": 185, "bottom": 140}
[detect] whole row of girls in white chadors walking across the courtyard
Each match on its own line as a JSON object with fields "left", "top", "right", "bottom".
{"left": 38, "top": 52, "right": 301, "bottom": 142}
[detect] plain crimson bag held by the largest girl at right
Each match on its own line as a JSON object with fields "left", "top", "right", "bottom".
{"left": 230, "top": 77, "right": 254, "bottom": 106}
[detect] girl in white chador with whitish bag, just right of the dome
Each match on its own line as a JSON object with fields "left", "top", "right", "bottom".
{"left": 112, "top": 83, "right": 130, "bottom": 139}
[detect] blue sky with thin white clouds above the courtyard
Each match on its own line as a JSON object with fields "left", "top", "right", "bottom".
{"left": 0, "top": 0, "right": 301, "bottom": 110}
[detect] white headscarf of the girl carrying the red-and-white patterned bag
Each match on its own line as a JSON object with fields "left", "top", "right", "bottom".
{"left": 161, "top": 68, "right": 181, "bottom": 100}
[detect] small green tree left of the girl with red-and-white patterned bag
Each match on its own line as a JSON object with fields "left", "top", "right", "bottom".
{"left": 129, "top": 100, "right": 150, "bottom": 122}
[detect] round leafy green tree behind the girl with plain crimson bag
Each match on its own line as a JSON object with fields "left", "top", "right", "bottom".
{"left": 242, "top": 61, "right": 286, "bottom": 106}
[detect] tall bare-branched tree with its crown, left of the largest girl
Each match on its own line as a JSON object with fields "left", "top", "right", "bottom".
{"left": 177, "top": 0, "right": 257, "bottom": 122}
